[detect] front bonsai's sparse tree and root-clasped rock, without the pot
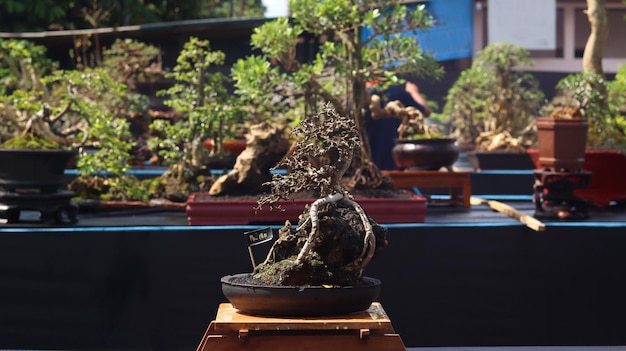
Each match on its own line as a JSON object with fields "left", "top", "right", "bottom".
{"left": 253, "top": 104, "right": 386, "bottom": 285}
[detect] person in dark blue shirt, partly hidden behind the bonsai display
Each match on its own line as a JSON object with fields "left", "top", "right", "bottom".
{"left": 365, "top": 81, "right": 430, "bottom": 170}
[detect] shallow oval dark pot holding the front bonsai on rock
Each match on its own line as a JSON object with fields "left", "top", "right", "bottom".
{"left": 221, "top": 273, "right": 381, "bottom": 317}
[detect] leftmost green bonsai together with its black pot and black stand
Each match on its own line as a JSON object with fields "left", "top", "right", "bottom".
{"left": 0, "top": 40, "right": 136, "bottom": 223}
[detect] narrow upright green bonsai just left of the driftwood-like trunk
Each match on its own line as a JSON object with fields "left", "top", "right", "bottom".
{"left": 149, "top": 37, "right": 245, "bottom": 199}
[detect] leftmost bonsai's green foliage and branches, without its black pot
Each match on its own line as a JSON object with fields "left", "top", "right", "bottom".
{"left": 0, "top": 41, "right": 131, "bottom": 173}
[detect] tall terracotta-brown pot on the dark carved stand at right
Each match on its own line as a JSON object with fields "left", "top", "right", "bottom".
{"left": 536, "top": 117, "right": 589, "bottom": 172}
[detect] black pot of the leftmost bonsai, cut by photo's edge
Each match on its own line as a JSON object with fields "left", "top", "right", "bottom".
{"left": 0, "top": 149, "right": 76, "bottom": 193}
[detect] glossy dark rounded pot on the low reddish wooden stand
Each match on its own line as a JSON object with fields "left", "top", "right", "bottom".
{"left": 392, "top": 138, "right": 459, "bottom": 171}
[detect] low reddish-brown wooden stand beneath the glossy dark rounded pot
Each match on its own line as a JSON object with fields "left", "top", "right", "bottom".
{"left": 381, "top": 171, "right": 472, "bottom": 208}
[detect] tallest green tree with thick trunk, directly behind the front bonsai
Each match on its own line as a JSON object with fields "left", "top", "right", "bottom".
{"left": 234, "top": 0, "right": 441, "bottom": 187}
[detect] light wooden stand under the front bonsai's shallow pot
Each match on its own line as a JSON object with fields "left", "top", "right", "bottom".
{"left": 197, "top": 302, "right": 406, "bottom": 351}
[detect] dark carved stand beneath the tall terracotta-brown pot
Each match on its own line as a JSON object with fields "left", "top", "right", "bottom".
{"left": 533, "top": 170, "right": 591, "bottom": 219}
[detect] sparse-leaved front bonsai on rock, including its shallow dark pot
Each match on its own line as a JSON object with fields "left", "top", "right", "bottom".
{"left": 222, "top": 105, "right": 386, "bottom": 316}
